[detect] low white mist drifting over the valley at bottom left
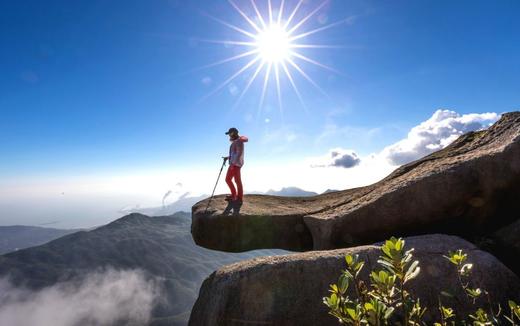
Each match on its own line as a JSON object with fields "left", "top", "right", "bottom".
{"left": 0, "top": 269, "right": 160, "bottom": 326}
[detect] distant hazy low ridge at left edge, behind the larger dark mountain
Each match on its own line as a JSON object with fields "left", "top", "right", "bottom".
{"left": 0, "top": 225, "right": 79, "bottom": 255}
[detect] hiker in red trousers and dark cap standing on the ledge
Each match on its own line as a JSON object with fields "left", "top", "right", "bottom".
{"left": 224, "top": 128, "right": 248, "bottom": 203}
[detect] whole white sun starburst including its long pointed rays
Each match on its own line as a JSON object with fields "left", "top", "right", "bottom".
{"left": 197, "top": 0, "right": 349, "bottom": 119}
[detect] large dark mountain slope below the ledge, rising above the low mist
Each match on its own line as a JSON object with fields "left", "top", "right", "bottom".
{"left": 0, "top": 212, "right": 285, "bottom": 325}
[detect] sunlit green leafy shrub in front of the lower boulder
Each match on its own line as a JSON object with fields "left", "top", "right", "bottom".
{"left": 323, "top": 237, "right": 520, "bottom": 326}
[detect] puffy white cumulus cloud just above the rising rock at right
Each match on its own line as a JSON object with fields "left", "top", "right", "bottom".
{"left": 382, "top": 110, "right": 500, "bottom": 165}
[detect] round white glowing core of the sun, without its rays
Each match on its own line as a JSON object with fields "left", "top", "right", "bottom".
{"left": 255, "top": 23, "right": 291, "bottom": 63}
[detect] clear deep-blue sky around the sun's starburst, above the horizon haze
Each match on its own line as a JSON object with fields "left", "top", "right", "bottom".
{"left": 0, "top": 0, "right": 520, "bottom": 228}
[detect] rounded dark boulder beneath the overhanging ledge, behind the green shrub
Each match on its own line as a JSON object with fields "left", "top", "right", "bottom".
{"left": 189, "top": 234, "right": 520, "bottom": 326}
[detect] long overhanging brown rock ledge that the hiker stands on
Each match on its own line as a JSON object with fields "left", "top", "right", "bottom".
{"left": 192, "top": 112, "right": 520, "bottom": 252}
